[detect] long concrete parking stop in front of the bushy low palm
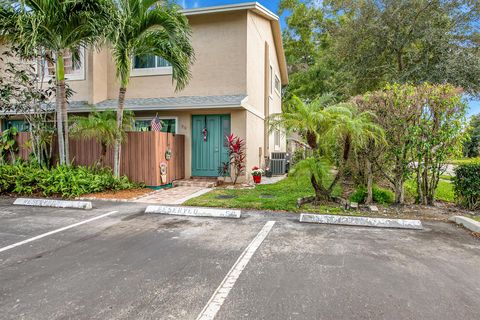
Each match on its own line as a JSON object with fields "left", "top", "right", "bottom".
{"left": 300, "top": 213, "right": 423, "bottom": 230}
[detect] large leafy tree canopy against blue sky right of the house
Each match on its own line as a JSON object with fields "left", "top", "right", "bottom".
{"left": 280, "top": 0, "right": 480, "bottom": 98}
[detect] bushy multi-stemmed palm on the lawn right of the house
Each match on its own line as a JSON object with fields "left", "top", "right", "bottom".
{"left": 270, "top": 95, "right": 384, "bottom": 203}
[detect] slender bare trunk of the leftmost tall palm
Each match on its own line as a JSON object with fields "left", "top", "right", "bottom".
{"left": 55, "top": 52, "right": 65, "bottom": 165}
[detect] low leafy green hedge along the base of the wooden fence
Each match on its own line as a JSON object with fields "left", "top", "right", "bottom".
{"left": 0, "top": 162, "right": 136, "bottom": 198}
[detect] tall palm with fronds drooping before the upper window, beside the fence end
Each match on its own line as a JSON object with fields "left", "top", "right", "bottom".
{"left": 108, "top": 0, "right": 194, "bottom": 176}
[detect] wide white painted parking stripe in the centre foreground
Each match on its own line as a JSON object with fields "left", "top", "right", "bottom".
{"left": 197, "top": 221, "right": 275, "bottom": 320}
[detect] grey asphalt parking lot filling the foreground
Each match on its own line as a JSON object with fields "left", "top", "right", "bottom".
{"left": 0, "top": 199, "right": 480, "bottom": 319}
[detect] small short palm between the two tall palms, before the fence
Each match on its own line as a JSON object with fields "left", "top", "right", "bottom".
{"left": 70, "top": 108, "right": 133, "bottom": 166}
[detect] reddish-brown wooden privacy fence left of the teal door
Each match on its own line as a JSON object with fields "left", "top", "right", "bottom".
{"left": 17, "top": 131, "right": 185, "bottom": 186}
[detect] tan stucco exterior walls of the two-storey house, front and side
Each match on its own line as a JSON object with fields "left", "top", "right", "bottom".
{"left": 1, "top": 3, "right": 288, "bottom": 179}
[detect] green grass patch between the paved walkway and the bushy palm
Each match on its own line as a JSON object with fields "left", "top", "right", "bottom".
{"left": 185, "top": 177, "right": 343, "bottom": 213}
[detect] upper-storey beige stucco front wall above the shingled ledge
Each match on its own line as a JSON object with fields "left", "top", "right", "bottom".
{"left": 108, "top": 11, "right": 247, "bottom": 99}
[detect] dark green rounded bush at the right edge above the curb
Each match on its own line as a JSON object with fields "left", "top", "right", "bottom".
{"left": 452, "top": 163, "right": 480, "bottom": 210}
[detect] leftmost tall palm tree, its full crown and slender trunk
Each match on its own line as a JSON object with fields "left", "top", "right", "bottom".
{"left": 0, "top": 0, "right": 110, "bottom": 164}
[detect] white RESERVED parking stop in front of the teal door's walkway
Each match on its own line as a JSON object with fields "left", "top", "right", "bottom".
{"left": 145, "top": 205, "right": 241, "bottom": 219}
